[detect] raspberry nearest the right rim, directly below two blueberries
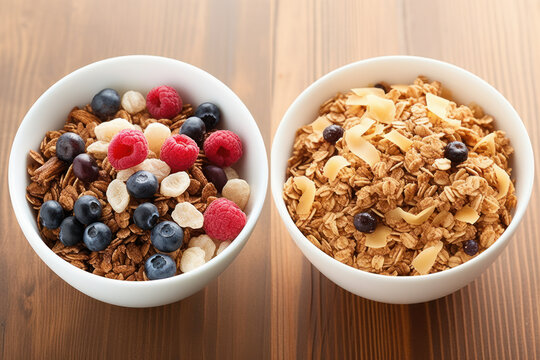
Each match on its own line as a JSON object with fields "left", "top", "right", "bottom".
{"left": 204, "top": 130, "right": 242, "bottom": 167}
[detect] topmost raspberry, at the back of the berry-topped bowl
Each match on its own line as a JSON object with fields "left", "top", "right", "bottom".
{"left": 146, "top": 85, "right": 182, "bottom": 119}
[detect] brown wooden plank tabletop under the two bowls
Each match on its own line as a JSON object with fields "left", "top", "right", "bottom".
{"left": 0, "top": 0, "right": 540, "bottom": 359}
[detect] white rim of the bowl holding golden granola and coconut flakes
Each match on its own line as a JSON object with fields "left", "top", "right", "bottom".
{"left": 270, "top": 55, "right": 534, "bottom": 283}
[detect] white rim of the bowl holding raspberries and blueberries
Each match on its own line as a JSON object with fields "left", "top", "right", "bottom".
{"left": 8, "top": 55, "right": 268, "bottom": 289}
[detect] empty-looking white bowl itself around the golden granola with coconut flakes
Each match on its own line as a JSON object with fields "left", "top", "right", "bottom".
{"left": 271, "top": 56, "right": 534, "bottom": 304}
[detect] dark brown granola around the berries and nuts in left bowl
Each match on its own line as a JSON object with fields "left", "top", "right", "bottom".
{"left": 26, "top": 101, "right": 230, "bottom": 280}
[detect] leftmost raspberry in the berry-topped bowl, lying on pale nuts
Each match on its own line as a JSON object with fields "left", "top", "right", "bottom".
{"left": 107, "top": 129, "right": 148, "bottom": 170}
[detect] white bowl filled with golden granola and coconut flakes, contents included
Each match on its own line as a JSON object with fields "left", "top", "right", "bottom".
{"left": 271, "top": 56, "right": 534, "bottom": 304}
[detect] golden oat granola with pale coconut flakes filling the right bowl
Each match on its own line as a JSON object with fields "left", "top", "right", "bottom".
{"left": 283, "top": 76, "right": 517, "bottom": 275}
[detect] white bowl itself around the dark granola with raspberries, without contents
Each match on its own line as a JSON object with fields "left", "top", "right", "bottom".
{"left": 9, "top": 55, "right": 268, "bottom": 307}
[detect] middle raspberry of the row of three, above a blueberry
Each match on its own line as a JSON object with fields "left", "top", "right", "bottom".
{"left": 160, "top": 134, "right": 199, "bottom": 173}
